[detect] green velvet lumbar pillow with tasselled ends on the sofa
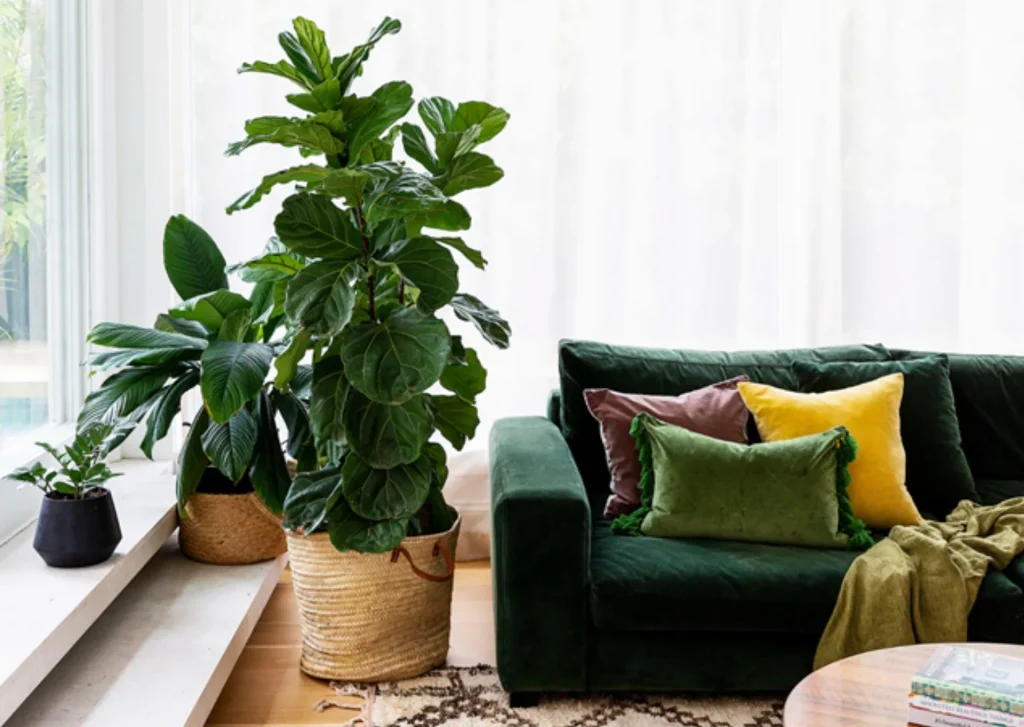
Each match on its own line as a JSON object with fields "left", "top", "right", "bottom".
{"left": 611, "top": 414, "right": 872, "bottom": 548}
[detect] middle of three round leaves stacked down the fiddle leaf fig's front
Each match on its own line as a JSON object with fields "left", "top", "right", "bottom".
{"left": 342, "top": 388, "right": 432, "bottom": 469}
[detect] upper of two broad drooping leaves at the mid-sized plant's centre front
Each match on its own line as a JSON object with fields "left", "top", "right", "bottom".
{"left": 200, "top": 339, "right": 273, "bottom": 423}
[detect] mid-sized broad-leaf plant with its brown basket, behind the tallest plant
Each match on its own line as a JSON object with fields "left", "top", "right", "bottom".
{"left": 78, "top": 215, "right": 305, "bottom": 563}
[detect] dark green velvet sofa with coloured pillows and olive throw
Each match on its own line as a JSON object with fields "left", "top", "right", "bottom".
{"left": 490, "top": 341, "right": 1024, "bottom": 703}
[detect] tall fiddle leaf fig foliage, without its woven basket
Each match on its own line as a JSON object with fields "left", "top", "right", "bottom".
{"left": 228, "top": 17, "right": 510, "bottom": 553}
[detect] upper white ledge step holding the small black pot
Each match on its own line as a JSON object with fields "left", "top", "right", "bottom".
{"left": 0, "top": 461, "right": 177, "bottom": 724}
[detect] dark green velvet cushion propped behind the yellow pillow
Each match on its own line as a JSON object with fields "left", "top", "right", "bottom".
{"left": 794, "top": 355, "right": 978, "bottom": 518}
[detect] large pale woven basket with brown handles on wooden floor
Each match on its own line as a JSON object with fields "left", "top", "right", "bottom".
{"left": 288, "top": 517, "right": 462, "bottom": 682}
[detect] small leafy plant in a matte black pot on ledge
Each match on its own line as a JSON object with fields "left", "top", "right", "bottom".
{"left": 7, "top": 424, "right": 121, "bottom": 568}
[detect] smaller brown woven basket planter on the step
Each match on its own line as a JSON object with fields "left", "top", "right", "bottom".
{"left": 178, "top": 493, "right": 288, "bottom": 565}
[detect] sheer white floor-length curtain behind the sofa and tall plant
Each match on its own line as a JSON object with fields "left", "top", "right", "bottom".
{"left": 182, "top": 0, "right": 1024, "bottom": 556}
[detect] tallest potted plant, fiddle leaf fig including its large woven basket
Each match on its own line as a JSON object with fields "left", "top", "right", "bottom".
{"left": 227, "top": 17, "right": 509, "bottom": 681}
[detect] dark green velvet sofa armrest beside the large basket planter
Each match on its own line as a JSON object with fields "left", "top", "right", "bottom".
{"left": 490, "top": 417, "right": 590, "bottom": 691}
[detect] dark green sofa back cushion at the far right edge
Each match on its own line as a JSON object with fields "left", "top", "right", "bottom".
{"left": 890, "top": 349, "right": 1024, "bottom": 481}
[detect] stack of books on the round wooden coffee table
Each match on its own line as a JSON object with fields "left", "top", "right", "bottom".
{"left": 908, "top": 646, "right": 1024, "bottom": 727}
